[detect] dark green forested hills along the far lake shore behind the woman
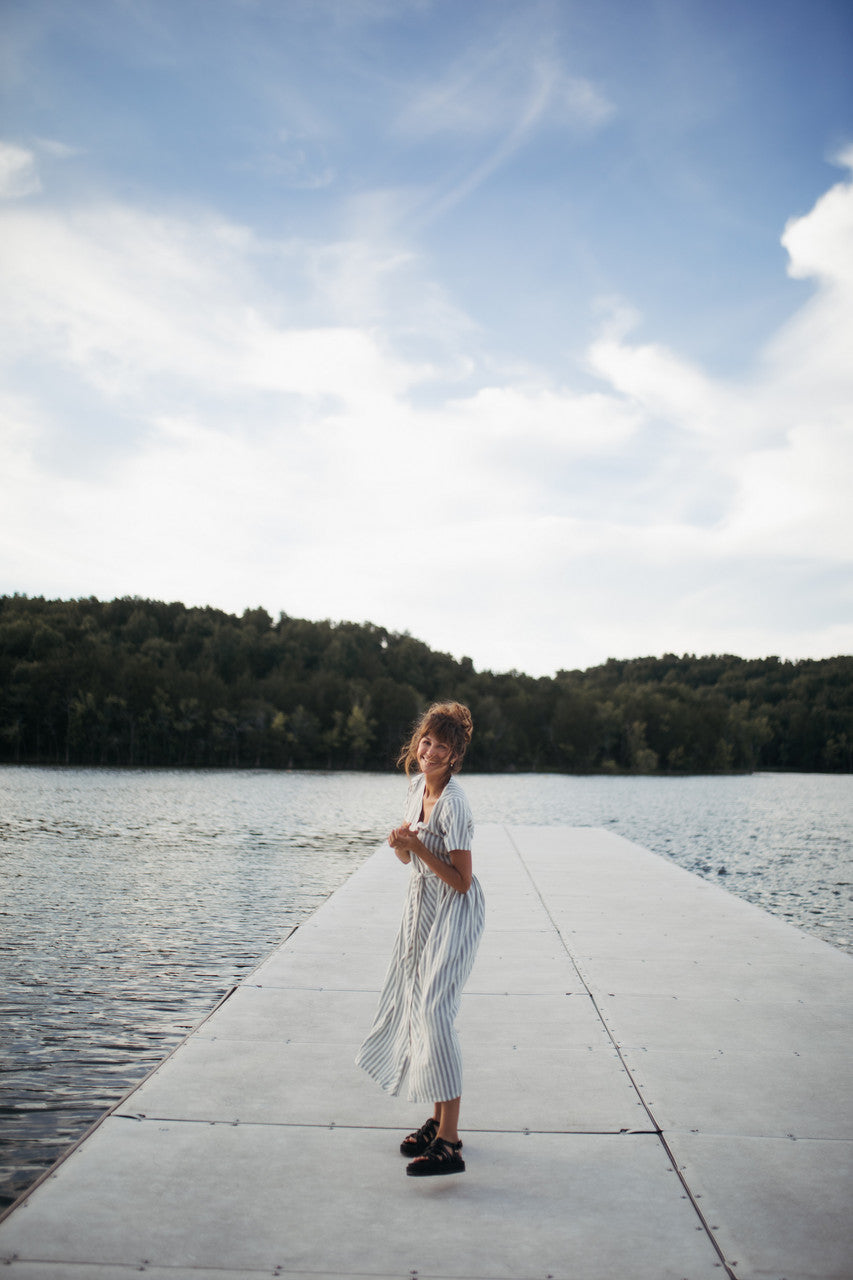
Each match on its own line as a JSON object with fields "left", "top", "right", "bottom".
{"left": 0, "top": 595, "right": 853, "bottom": 774}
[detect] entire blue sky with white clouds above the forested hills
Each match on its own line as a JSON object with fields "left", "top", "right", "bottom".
{"left": 0, "top": 0, "right": 853, "bottom": 676}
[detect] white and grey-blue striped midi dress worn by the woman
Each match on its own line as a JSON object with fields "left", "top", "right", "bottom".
{"left": 356, "top": 774, "right": 485, "bottom": 1102}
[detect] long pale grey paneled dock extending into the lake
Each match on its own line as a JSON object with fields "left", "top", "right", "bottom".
{"left": 0, "top": 826, "right": 853, "bottom": 1280}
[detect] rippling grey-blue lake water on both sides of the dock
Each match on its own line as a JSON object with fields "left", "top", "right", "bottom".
{"left": 0, "top": 767, "right": 853, "bottom": 1208}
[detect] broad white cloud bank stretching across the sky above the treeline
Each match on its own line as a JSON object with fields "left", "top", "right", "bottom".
{"left": 0, "top": 151, "right": 853, "bottom": 673}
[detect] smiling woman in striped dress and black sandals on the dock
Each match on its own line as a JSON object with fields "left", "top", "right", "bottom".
{"left": 356, "top": 703, "right": 484, "bottom": 1178}
